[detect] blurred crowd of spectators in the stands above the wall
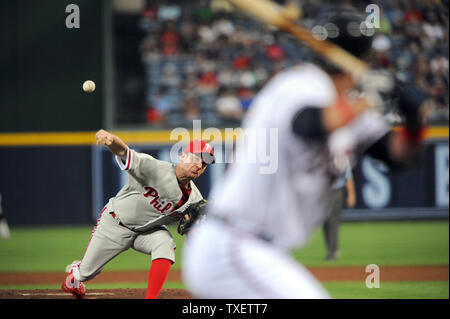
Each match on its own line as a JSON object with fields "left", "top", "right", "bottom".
{"left": 139, "top": 0, "right": 449, "bottom": 126}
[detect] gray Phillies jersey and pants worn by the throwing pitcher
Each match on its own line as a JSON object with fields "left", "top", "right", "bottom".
{"left": 74, "top": 149, "right": 203, "bottom": 281}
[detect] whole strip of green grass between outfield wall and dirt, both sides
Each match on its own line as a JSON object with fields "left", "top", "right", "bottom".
{"left": 0, "top": 221, "right": 449, "bottom": 272}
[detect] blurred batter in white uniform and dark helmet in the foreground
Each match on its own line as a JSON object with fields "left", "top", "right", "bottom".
{"left": 182, "top": 10, "right": 423, "bottom": 299}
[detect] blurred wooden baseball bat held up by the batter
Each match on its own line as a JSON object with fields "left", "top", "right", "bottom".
{"left": 228, "top": 0, "right": 369, "bottom": 81}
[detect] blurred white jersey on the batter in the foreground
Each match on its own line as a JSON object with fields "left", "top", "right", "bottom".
{"left": 208, "top": 64, "right": 389, "bottom": 249}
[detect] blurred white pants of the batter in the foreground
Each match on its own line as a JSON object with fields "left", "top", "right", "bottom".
{"left": 182, "top": 219, "right": 330, "bottom": 299}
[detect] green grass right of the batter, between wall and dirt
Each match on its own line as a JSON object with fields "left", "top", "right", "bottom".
{"left": 295, "top": 221, "right": 449, "bottom": 266}
